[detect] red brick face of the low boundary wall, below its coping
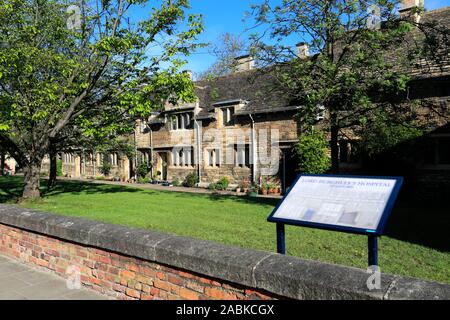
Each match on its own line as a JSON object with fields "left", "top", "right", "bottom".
{"left": 0, "top": 224, "right": 274, "bottom": 300}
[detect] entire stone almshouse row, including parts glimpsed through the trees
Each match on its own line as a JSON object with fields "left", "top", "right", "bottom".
{"left": 53, "top": 0, "right": 450, "bottom": 196}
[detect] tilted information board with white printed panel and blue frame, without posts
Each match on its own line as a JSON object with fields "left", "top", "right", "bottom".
{"left": 268, "top": 175, "right": 403, "bottom": 236}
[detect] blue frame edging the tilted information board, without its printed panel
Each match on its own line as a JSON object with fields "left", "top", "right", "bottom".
{"left": 267, "top": 174, "right": 403, "bottom": 237}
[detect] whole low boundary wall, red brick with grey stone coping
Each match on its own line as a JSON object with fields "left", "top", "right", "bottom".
{"left": 0, "top": 204, "right": 450, "bottom": 300}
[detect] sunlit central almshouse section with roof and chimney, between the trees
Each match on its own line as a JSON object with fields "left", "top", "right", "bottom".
{"left": 136, "top": 56, "right": 299, "bottom": 190}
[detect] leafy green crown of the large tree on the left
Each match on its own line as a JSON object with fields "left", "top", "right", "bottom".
{"left": 0, "top": 0, "right": 203, "bottom": 192}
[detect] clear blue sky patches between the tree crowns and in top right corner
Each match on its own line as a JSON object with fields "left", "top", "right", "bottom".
{"left": 182, "top": 0, "right": 450, "bottom": 73}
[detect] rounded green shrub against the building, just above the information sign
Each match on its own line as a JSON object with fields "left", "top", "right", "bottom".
{"left": 295, "top": 129, "right": 331, "bottom": 174}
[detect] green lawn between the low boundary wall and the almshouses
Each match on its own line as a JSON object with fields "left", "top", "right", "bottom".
{"left": 0, "top": 177, "right": 450, "bottom": 283}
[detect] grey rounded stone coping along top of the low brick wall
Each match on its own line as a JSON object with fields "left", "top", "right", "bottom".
{"left": 0, "top": 204, "right": 450, "bottom": 300}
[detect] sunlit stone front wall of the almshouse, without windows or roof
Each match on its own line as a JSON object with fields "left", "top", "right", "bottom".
{"left": 136, "top": 106, "right": 298, "bottom": 184}
